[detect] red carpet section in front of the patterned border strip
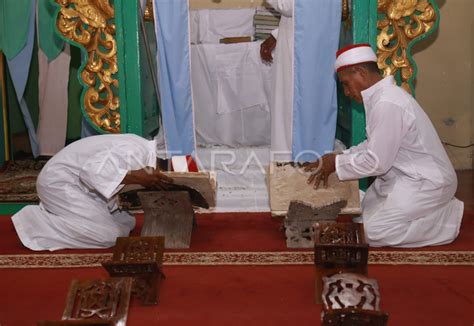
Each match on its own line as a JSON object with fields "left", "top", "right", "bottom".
{"left": 0, "top": 266, "right": 474, "bottom": 326}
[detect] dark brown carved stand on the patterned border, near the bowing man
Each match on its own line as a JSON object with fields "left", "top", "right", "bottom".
{"left": 102, "top": 237, "right": 164, "bottom": 305}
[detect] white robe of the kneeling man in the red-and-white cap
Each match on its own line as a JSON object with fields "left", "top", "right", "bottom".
{"left": 336, "top": 76, "right": 464, "bottom": 247}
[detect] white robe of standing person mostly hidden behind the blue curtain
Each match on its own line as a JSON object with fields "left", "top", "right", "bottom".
{"left": 267, "top": 0, "right": 294, "bottom": 161}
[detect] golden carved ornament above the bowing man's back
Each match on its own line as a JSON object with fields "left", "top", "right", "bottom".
{"left": 55, "top": 0, "right": 120, "bottom": 133}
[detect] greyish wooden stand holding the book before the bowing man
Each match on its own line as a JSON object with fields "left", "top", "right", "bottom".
{"left": 138, "top": 191, "right": 194, "bottom": 248}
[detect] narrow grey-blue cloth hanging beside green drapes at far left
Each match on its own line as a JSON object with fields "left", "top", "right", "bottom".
{"left": 3, "top": 1, "right": 39, "bottom": 157}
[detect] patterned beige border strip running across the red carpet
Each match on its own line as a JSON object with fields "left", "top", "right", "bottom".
{"left": 0, "top": 251, "right": 474, "bottom": 269}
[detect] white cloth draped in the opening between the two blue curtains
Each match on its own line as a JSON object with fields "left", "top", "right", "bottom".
{"left": 191, "top": 42, "right": 271, "bottom": 147}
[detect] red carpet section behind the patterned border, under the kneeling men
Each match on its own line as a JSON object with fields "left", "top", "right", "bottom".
{"left": 0, "top": 212, "right": 474, "bottom": 255}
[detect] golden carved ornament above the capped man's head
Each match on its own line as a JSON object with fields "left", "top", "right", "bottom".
{"left": 377, "top": 0, "right": 437, "bottom": 92}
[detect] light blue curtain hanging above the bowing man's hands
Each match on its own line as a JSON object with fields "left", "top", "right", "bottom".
{"left": 153, "top": 0, "right": 196, "bottom": 155}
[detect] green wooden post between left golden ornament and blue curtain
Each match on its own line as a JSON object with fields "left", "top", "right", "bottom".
{"left": 115, "top": 0, "right": 159, "bottom": 137}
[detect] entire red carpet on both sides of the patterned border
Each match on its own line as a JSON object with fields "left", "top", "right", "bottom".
{"left": 0, "top": 213, "right": 474, "bottom": 326}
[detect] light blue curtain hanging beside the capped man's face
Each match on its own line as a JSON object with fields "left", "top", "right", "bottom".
{"left": 292, "top": 0, "right": 342, "bottom": 162}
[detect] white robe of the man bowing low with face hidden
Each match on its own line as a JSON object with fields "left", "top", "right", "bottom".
{"left": 12, "top": 134, "right": 156, "bottom": 251}
